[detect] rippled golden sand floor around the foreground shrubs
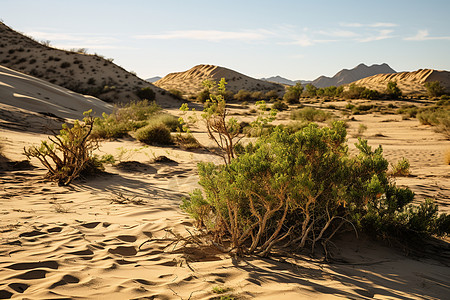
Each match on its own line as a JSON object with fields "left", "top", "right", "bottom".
{"left": 0, "top": 102, "right": 450, "bottom": 299}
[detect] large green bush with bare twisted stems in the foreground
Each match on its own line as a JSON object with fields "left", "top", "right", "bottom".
{"left": 181, "top": 122, "right": 450, "bottom": 256}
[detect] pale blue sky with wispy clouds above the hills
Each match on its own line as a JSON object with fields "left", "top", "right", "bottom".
{"left": 0, "top": 0, "right": 450, "bottom": 80}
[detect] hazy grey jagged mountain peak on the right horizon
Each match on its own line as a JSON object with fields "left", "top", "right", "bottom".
{"left": 311, "top": 63, "right": 397, "bottom": 88}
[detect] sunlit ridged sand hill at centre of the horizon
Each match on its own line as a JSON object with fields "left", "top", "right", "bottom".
{"left": 155, "top": 65, "right": 284, "bottom": 96}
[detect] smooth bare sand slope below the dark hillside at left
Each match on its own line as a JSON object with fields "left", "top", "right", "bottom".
{"left": 0, "top": 66, "right": 112, "bottom": 131}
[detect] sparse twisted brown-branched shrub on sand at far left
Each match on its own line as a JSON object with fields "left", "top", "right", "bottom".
{"left": 24, "top": 110, "right": 102, "bottom": 185}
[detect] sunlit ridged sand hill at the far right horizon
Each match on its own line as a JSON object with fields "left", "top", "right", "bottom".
{"left": 353, "top": 69, "right": 450, "bottom": 94}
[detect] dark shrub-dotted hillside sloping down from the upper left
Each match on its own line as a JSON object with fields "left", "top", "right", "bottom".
{"left": 0, "top": 22, "right": 173, "bottom": 105}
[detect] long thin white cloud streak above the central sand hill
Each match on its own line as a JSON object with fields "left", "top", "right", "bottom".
{"left": 134, "top": 30, "right": 272, "bottom": 42}
